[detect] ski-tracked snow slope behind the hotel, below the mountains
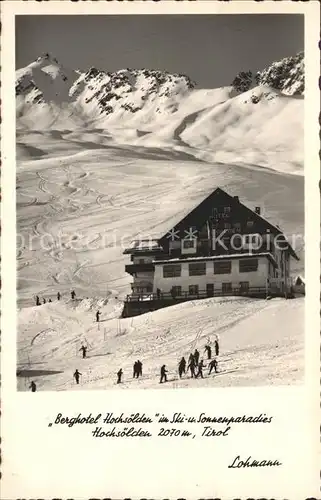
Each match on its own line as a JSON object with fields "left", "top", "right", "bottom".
{"left": 17, "top": 142, "right": 304, "bottom": 312}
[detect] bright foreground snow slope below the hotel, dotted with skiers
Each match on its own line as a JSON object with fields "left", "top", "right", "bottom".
{"left": 18, "top": 298, "right": 304, "bottom": 390}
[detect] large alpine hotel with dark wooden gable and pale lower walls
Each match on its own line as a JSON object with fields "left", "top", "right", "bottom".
{"left": 124, "top": 188, "right": 299, "bottom": 316}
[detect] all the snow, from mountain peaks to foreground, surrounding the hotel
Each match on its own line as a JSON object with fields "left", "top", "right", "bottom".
{"left": 16, "top": 55, "right": 304, "bottom": 390}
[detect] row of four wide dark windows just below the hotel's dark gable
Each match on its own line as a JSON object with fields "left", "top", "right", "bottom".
{"left": 163, "top": 259, "right": 259, "bottom": 278}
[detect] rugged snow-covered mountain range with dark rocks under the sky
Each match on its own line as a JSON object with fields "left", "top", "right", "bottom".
{"left": 16, "top": 53, "right": 304, "bottom": 172}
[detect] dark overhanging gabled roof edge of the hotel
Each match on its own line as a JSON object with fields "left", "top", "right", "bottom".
{"left": 158, "top": 188, "right": 300, "bottom": 260}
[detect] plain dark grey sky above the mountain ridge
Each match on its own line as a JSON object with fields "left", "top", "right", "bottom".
{"left": 16, "top": 14, "right": 304, "bottom": 88}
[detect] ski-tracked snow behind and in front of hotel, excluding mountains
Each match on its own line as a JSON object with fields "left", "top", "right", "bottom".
{"left": 17, "top": 129, "right": 304, "bottom": 390}
